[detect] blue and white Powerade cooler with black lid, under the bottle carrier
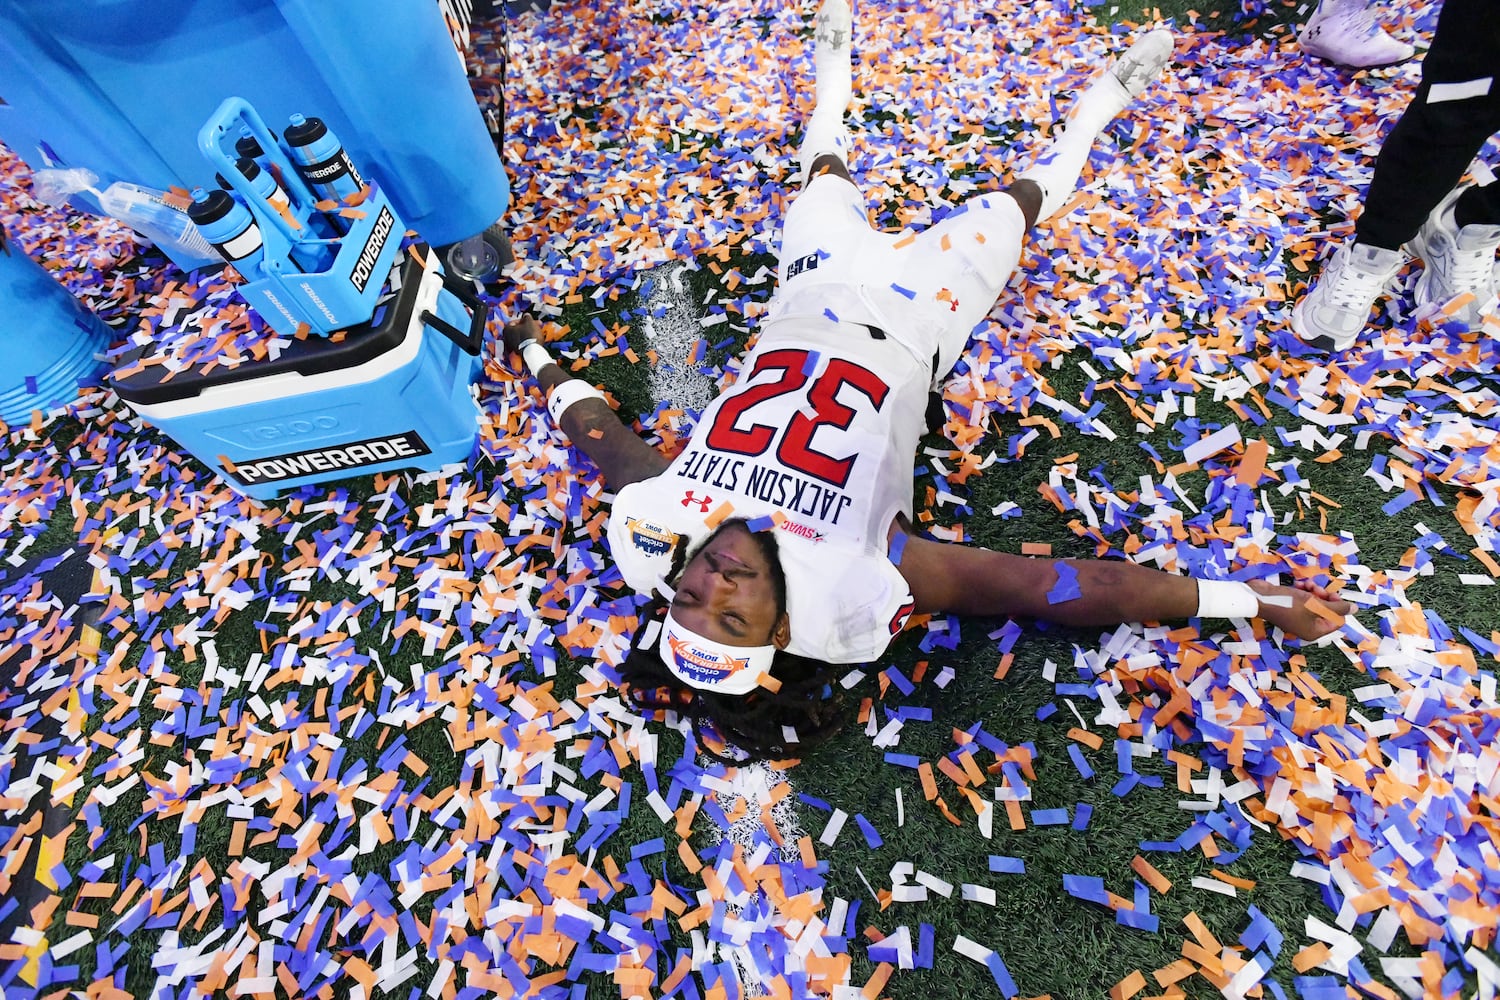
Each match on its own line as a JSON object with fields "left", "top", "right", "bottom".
{"left": 113, "top": 244, "right": 488, "bottom": 501}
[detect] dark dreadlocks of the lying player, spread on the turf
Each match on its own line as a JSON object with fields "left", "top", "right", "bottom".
{"left": 620, "top": 522, "right": 845, "bottom": 763}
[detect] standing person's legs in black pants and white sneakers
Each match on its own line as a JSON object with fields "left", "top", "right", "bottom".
{"left": 1292, "top": 0, "right": 1500, "bottom": 351}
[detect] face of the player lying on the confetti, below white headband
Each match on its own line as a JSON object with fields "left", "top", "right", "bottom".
{"left": 672, "top": 522, "right": 789, "bottom": 648}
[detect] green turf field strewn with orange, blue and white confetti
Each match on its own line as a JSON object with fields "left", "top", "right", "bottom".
{"left": 0, "top": 3, "right": 1500, "bottom": 999}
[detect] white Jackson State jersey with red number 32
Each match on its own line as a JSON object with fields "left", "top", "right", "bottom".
{"left": 609, "top": 316, "right": 930, "bottom": 663}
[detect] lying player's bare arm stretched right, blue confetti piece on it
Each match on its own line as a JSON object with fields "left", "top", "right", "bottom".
{"left": 891, "top": 526, "right": 1350, "bottom": 639}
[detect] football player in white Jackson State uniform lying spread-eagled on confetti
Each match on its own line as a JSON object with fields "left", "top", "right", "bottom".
{"left": 506, "top": 0, "right": 1349, "bottom": 759}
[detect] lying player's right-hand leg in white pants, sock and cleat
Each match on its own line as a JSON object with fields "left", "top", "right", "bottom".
{"left": 888, "top": 28, "right": 1173, "bottom": 376}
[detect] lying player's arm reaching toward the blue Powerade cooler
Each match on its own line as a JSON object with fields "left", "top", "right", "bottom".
{"left": 504, "top": 316, "right": 669, "bottom": 490}
